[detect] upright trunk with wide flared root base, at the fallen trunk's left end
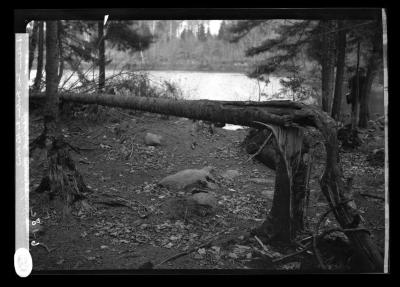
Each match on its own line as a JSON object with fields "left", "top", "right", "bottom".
{"left": 31, "top": 21, "right": 88, "bottom": 218}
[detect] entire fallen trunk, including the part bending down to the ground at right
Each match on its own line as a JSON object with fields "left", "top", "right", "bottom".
{"left": 32, "top": 94, "right": 383, "bottom": 271}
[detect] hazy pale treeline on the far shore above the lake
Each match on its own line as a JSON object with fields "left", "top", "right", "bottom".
{"left": 107, "top": 21, "right": 268, "bottom": 73}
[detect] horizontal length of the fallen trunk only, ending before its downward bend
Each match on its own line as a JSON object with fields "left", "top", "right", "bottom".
{"left": 31, "top": 93, "right": 315, "bottom": 128}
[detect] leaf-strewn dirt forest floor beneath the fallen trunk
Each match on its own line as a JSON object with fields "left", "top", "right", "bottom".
{"left": 30, "top": 104, "right": 385, "bottom": 272}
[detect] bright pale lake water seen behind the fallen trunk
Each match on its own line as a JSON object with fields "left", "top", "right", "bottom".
{"left": 30, "top": 70, "right": 383, "bottom": 118}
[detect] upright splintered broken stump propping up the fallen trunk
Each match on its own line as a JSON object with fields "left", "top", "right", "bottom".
{"left": 252, "top": 126, "right": 308, "bottom": 242}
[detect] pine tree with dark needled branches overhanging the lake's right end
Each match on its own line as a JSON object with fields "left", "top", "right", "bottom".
{"left": 228, "top": 20, "right": 334, "bottom": 111}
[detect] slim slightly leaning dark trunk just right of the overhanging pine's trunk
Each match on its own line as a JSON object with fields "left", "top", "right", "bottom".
{"left": 332, "top": 21, "right": 347, "bottom": 121}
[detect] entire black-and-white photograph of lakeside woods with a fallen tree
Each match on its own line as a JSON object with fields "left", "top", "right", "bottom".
{"left": 14, "top": 8, "right": 389, "bottom": 276}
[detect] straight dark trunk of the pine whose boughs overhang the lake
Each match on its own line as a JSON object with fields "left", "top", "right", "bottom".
{"left": 321, "top": 20, "right": 335, "bottom": 114}
